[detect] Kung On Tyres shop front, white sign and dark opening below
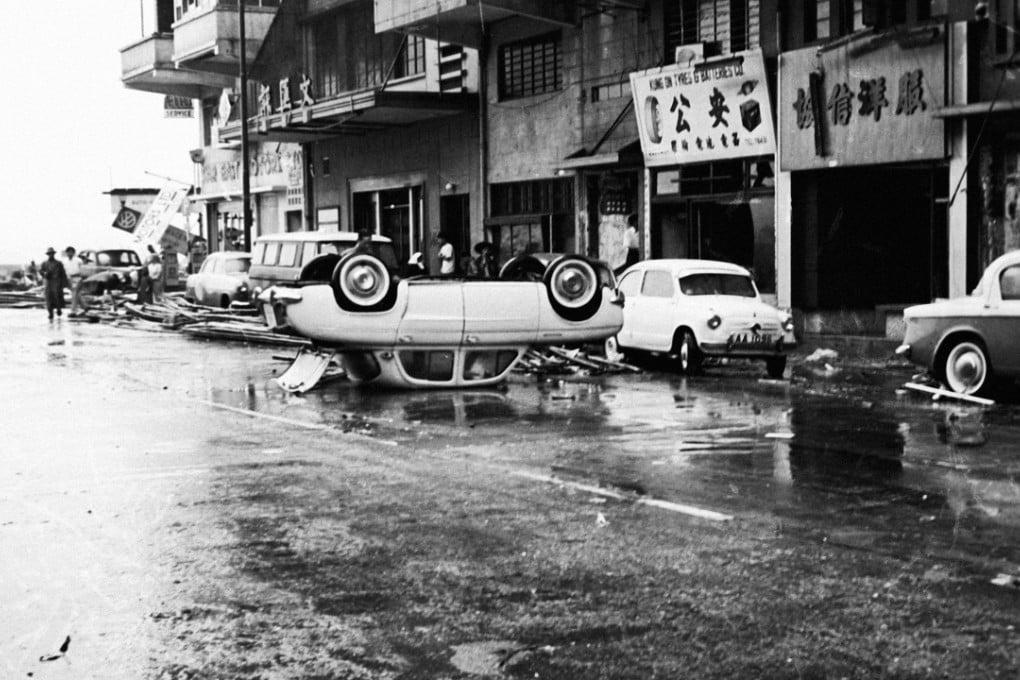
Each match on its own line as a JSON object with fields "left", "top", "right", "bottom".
{"left": 630, "top": 50, "right": 776, "bottom": 297}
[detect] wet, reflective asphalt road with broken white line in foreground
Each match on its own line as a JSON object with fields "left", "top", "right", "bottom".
{"left": 0, "top": 310, "right": 1020, "bottom": 678}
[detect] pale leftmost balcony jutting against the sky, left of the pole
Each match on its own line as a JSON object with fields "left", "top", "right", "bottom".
{"left": 120, "top": 34, "right": 234, "bottom": 99}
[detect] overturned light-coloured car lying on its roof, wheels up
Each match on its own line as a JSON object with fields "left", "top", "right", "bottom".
{"left": 258, "top": 251, "right": 623, "bottom": 391}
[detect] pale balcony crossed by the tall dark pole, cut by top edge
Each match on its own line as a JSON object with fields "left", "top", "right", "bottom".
{"left": 173, "top": 2, "right": 276, "bottom": 74}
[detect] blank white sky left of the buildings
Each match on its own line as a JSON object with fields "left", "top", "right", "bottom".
{"left": 0, "top": 0, "right": 201, "bottom": 264}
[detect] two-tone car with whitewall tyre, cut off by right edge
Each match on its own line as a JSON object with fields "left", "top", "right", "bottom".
{"left": 897, "top": 251, "right": 1020, "bottom": 396}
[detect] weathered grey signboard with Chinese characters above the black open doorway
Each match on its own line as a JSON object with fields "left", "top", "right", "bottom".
{"left": 779, "top": 39, "right": 946, "bottom": 170}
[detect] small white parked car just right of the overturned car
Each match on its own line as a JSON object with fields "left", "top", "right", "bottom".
{"left": 606, "top": 259, "right": 797, "bottom": 378}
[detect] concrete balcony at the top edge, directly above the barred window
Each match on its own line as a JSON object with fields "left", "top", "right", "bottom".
{"left": 375, "top": 0, "right": 577, "bottom": 48}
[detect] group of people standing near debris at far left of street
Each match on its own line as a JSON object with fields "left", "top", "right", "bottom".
{"left": 37, "top": 246, "right": 164, "bottom": 321}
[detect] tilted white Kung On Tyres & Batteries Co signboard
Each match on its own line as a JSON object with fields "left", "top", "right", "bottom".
{"left": 630, "top": 50, "right": 775, "bottom": 167}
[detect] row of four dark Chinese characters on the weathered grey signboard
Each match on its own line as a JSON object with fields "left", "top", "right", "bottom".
{"left": 793, "top": 68, "right": 927, "bottom": 129}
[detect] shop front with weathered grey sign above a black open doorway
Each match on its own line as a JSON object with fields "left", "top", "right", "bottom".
{"left": 779, "top": 27, "right": 951, "bottom": 334}
